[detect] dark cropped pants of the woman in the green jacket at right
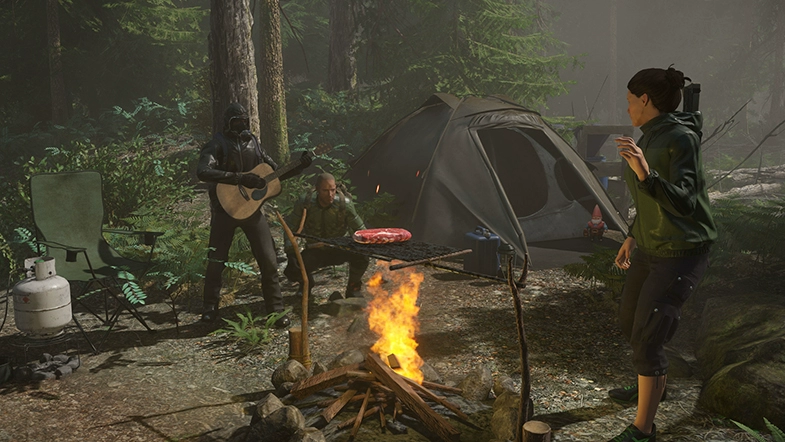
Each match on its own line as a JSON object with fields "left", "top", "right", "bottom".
{"left": 619, "top": 250, "right": 709, "bottom": 376}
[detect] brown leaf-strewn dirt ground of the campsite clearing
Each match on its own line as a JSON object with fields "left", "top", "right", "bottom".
{"left": 0, "top": 262, "right": 752, "bottom": 442}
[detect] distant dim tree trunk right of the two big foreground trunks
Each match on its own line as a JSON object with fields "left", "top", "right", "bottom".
{"left": 327, "top": 0, "right": 357, "bottom": 92}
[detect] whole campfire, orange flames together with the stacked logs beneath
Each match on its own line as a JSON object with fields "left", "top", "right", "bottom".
{"left": 290, "top": 269, "right": 471, "bottom": 441}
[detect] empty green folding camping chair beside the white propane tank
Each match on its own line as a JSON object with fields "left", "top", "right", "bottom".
{"left": 30, "top": 171, "right": 162, "bottom": 353}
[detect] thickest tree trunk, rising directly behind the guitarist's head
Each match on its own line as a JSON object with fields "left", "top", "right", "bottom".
{"left": 208, "top": 0, "right": 259, "bottom": 134}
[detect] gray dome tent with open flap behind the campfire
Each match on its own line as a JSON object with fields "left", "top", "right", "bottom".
{"left": 346, "top": 93, "right": 627, "bottom": 262}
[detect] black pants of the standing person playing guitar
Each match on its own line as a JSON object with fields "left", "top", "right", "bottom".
{"left": 204, "top": 208, "right": 283, "bottom": 313}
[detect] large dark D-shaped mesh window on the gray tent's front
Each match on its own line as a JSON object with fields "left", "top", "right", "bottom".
{"left": 477, "top": 129, "right": 548, "bottom": 218}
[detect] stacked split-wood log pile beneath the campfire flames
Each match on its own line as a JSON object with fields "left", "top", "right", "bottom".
{"left": 290, "top": 353, "right": 473, "bottom": 441}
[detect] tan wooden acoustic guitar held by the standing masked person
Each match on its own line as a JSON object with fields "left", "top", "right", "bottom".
{"left": 215, "top": 143, "right": 332, "bottom": 220}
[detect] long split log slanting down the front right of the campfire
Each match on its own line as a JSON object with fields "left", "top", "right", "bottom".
{"left": 365, "top": 353, "right": 461, "bottom": 441}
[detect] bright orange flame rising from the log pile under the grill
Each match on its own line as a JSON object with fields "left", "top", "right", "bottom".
{"left": 367, "top": 265, "right": 423, "bottom": 384}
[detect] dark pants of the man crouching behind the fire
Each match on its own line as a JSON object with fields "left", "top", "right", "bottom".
{"left": 284, "top": 247, "right": 370, "bottom": 296}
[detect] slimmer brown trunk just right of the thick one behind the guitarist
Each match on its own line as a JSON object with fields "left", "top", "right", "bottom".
{"left": 258, "top": 0, "right": 289, "bottom": 164}
